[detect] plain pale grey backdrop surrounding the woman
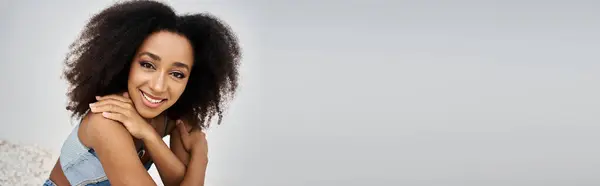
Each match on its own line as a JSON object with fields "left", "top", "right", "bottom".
{"left": 0, "top": 0, "right": 600, "bottom": 186}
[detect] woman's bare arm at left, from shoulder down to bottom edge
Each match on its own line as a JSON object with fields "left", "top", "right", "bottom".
{"left": 82, "top": 113, "right": 156, "bottom": 186}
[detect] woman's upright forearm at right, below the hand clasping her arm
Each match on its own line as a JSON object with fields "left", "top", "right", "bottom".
{"left": 181, "top": 150, "right": 208, "bottom": 186}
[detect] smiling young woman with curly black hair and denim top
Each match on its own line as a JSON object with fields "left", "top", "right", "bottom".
{"left": 44, "top": 1, "right": 240, "bottom": 186}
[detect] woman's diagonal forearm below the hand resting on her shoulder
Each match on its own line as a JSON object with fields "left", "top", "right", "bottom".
{"left": 143, "top": 133, "right": 186, "bottom": 185}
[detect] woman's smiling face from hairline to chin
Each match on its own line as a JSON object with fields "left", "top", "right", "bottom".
{"left": 127, "top": 31, "right": 194, "bottom": 118}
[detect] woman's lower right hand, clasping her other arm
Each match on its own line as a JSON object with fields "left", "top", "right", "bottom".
{"left": 176, "top": 120, "right": 208, "bottom": 162}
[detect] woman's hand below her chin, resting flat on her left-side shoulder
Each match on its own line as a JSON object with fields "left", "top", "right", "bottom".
{"left": 90, "top": 92, "right": 154, "bottom": 140}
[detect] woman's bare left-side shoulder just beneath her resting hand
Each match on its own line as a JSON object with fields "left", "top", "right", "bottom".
{"left": 78, "top": 113, "right": 133, "bottom": 148}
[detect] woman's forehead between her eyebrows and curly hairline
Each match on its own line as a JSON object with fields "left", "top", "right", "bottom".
{"left": 138, "top": 31, "right": 194, "bottom": 66}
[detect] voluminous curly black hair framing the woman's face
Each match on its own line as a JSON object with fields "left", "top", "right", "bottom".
{"left": 63, "top": 1, "right": 241, "bottom": 128}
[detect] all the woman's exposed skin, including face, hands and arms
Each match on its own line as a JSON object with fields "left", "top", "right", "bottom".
{"left": 50, "top": 31, "right": 208, "bottom": 185}
